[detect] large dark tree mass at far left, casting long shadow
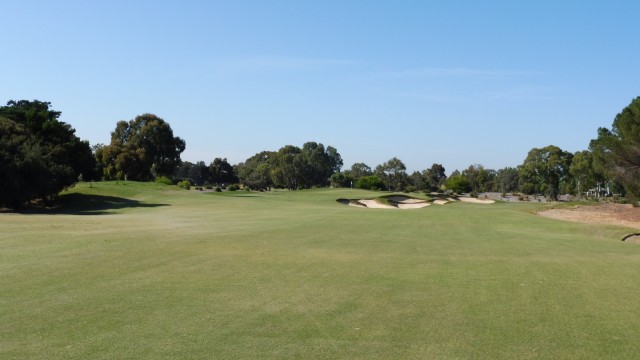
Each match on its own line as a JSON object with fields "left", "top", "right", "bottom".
{"left": 0, "top": 100, "right": 95, "bottom": 208}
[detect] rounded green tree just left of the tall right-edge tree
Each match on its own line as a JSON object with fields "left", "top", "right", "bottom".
{"left": 518, "top": 145, "right": 573, "bottom": 200}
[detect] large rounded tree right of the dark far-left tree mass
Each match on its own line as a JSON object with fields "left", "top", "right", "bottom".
{"left": 98, "top": 114, "right": 186, "bottom": 181}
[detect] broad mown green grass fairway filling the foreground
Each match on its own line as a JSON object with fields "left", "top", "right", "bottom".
{"left": 0, "top": 182, "right": 640, "bottom": 359}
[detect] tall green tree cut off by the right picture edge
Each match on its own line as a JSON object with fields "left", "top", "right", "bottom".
{"left": 589, "top": 97, "right": 640, "bottom": 198}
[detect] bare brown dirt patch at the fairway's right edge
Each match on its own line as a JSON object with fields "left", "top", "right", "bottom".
{"left": 538, "top": 204, "right": 640, "bottom": 229}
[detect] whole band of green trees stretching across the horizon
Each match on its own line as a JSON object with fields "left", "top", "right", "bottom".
{"left": 0, "top": 97, "right": 640, "bottom": 208}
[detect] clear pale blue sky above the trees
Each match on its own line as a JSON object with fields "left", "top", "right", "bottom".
{"left": 0, "top": 0, "right": 640, "bottom": 173}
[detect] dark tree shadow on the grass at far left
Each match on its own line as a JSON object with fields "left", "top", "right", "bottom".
{"left": 1, "top": 193, "right": 169, "bottom": 215}
